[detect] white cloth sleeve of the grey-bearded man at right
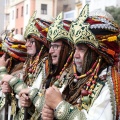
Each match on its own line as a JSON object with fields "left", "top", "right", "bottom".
{"left": 82, "top": 83, "right": 113, "bottom": 120}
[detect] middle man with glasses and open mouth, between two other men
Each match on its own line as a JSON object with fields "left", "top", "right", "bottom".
{"left": 19, "top": 13, "right": 74, "bottom": 119}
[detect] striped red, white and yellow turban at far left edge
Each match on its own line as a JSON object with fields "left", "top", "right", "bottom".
{"left": 2, "top": 31, "right": 26, "bottom": 61}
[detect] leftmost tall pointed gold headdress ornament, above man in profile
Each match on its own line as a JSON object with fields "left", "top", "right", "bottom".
{"left": 24, "top": 11, "right": 40, "bottom": 38}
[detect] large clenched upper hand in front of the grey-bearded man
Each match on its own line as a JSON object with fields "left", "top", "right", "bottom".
{"left": 45, "top": 86, "right": 63, "bottom": 109}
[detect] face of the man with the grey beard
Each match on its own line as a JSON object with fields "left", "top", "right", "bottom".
{"left": 74, "top": 44, "right": 88, "bottom": 73}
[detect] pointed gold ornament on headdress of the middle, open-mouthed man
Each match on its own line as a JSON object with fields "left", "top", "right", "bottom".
{"left": 47, "top": 13, "right": 69, "bottom": 42}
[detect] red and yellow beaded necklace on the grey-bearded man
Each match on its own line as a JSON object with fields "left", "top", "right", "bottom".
{"left": 73, "top": 56, "right": 101, "bottom": 104}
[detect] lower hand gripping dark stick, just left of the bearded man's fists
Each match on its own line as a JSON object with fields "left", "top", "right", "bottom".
{"left": 19, "top": 94, "right": 32, "bottom": 107}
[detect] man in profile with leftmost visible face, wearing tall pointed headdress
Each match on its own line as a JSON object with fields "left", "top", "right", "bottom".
{"left": 2, "top": 13, "right": 51, "bottom": 120}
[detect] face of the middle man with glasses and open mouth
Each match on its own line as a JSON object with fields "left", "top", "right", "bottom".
{"left": 49, "top": 41, "right": 62, "bottom": 65}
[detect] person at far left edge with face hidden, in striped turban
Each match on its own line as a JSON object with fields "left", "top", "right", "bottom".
{"left": 0, "top": 30, "right": 26, "bottom": 120}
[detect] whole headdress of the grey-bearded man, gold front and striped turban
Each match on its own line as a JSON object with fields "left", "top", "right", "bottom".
{"left": 69, "top": 5, "right": 120, "bottom": 64}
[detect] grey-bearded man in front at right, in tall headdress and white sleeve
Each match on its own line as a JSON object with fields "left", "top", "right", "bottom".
{"left": 42, "top": 5, "right": 120, "bottom": 120}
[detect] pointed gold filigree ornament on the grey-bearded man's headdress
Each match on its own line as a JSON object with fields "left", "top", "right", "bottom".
{"left": 69, "top": 5, "right": 98, "bottom": 48}
